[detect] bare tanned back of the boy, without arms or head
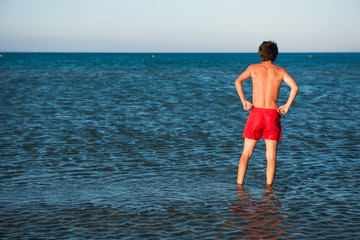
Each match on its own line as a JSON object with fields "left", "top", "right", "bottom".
{"left": 249, "top": 62, "right": 286, "bottom": 109}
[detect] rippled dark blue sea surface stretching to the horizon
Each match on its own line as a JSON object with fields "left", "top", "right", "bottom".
{"left": 0, "top": 53, "right": 360, "bottom": 239}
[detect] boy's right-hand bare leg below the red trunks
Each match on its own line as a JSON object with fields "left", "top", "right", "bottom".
{"left": 265, "top": 139, "right": 278, "bottom": 186}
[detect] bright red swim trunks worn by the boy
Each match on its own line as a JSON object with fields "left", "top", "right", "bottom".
{"left": 243, "top": 107, "right": 282, "bottom": 141}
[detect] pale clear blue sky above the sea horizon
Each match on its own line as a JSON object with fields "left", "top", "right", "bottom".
{"left": 0, "top": 0, "right": 360, "bottom": 52}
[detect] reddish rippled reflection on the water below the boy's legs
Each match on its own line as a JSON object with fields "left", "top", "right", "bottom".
{"left": 227, "top": 186, "right": 286, "bottom": 239}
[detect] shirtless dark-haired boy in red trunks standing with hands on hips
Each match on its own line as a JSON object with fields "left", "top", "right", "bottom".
{"left": 235, "top": 41, "right": 299, "bottom": 186}
